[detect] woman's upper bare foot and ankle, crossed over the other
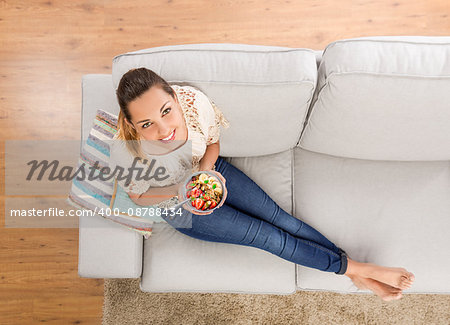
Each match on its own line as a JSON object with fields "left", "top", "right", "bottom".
{"left": 345, "top": 258, "right": 414, "bottom": 290}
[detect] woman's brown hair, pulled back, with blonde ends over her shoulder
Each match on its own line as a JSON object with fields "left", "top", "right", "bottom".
{"left": 116, "top": 68, "right": 176, "bottom": 159}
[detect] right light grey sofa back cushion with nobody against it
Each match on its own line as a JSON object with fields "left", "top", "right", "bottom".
{"left": 299, "top": 36, "right": 450, "bottom": 161}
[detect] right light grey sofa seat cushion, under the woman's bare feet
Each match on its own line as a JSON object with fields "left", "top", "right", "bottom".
{"left": 294, "top": 148, "right": 450, "bottom": 293}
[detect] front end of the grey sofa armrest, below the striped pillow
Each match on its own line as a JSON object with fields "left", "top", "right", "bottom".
{"left": 78, "top": 215, "right": 144, "bottom": 278}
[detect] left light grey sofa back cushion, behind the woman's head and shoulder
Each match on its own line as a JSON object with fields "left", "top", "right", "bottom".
{"left": 112, "top": 43, "right": 317, "bottom": 157}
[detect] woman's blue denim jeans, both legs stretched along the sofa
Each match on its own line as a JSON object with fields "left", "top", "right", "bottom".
{"left": 162, "top": 156, "right": 347, "bottom": 274}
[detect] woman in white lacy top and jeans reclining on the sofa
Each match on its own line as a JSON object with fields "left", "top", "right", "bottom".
{"left": 111, "top": 68, "right": 414, "bottom": 301}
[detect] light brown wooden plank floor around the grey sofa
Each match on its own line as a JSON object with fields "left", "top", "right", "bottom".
{"left": 0, "top": 0, "right": 450, "bottom": 324}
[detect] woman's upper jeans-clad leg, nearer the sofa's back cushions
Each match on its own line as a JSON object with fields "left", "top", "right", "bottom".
{"left": 215, "top": 156, "right": 347, "bottom": 270}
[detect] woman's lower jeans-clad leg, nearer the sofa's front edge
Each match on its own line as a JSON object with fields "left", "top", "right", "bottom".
{"left": 162, "top": 202, "right": 344, "bottom": 273}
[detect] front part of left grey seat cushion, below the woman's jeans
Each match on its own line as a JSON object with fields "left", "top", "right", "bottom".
{"left": 140, "top": 223, "right": 295, "bottom": 294}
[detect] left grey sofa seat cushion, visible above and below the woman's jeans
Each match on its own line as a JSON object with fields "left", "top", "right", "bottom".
{"left": 141, "top": 150, "right": 296, "bottom": 294}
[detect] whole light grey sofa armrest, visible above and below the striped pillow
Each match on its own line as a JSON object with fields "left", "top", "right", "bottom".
{"left": 78, "top": 74, "right": 143, "bottom": 278}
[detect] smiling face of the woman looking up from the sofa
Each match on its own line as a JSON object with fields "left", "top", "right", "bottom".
{"left": 128, "top": 86, "right": 187, "bottom": 154}
